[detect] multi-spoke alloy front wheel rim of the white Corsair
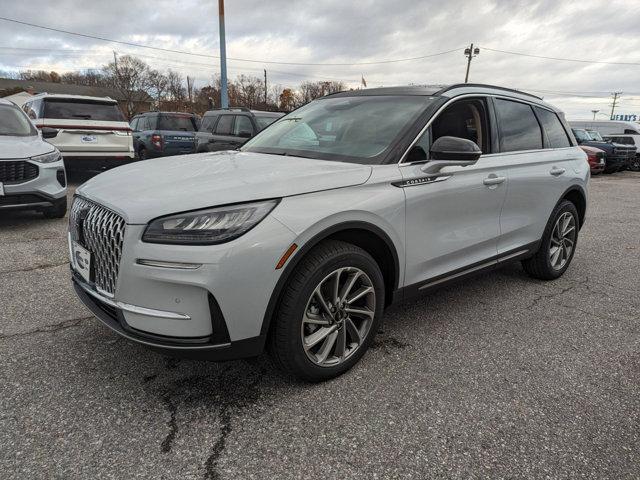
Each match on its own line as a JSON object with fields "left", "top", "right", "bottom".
{"left": 301, "top": 267, "right": 376, "bottom": 367}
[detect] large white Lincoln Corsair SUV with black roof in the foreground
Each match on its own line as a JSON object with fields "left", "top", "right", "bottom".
{"left": 69, "top": 85, "right": 589, "bottom": 381}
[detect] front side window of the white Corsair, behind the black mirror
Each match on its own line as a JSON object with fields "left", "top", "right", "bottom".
{"left": 405, "top": 99, "right": 491, "bottom": 162}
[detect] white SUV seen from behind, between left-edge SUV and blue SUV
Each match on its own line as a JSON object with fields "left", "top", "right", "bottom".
{"left": 22, "top": 93, "right": 134, "bottom": 170}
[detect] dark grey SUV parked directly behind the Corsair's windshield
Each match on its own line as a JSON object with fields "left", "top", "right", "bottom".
{"left": 196, "top": 107, "right": 284, "bottom": 153}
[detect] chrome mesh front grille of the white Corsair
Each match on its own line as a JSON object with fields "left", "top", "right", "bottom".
{"left": 69, "top": 197, "right": 125, "bottom": 295}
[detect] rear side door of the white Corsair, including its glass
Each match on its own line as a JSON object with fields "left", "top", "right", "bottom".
{"left": 494, "top": 98, "right": 584, "bottom": 254}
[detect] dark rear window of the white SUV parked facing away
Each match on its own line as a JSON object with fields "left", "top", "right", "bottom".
{"left": 43, "top": 98, "right": 125, "bottom": 122}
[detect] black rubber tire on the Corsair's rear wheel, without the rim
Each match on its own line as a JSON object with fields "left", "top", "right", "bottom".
{"left": 522, "top": 200, "right": 580, "bottom": 280}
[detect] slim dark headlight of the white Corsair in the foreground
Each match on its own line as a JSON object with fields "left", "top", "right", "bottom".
{"left": 142, "top": 200, "right": 279, "bottom": 245}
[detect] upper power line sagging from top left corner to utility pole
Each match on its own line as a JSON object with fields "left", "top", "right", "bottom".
{"left": 0, "top": 17, "right": 463, "bottom": 67}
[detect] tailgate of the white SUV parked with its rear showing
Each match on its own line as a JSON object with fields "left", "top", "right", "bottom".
{"left": 39, "top": 97, "right": 133, "bottom": 156}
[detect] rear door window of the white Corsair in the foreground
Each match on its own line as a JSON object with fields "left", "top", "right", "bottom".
{"left": 495, "top": 98, "right": 542, "bottom": 152}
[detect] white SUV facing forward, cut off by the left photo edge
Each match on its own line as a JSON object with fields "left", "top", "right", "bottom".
{"left": 0, "top": 98, "right": 67, "bottom": 218}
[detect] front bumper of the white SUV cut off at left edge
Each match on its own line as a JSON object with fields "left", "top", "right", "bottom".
{"left": 0, "top": 160, "right": 67, "bottom": 210}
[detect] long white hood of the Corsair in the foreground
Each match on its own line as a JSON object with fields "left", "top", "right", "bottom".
{"left": 77, "top": 151, "right": 371, "bottom": 224}
